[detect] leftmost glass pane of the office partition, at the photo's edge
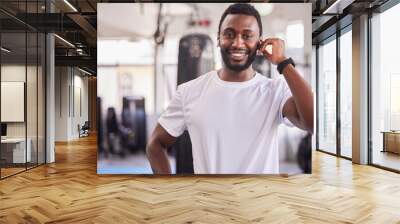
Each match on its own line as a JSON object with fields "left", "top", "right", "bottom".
{"left": 0, "top": 32, "right": 27, "bottom": 178}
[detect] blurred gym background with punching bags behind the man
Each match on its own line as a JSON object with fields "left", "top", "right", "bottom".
{"left": 97, "top": 3, "right": 315, "bottom": 174}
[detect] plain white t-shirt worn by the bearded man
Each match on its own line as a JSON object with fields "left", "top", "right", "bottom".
{"left": 158, "top": 71, "right": 291, "bottom": 174}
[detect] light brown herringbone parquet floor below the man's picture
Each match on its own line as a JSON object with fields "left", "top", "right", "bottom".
{"left": 0, "top": 134, "right": 400, "bottom": 224}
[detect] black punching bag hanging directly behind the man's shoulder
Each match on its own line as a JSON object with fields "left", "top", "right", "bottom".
{"left": 173, "top": 33, "right": 214, "bottom": 174}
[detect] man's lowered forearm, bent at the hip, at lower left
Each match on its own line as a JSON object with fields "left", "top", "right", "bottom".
{"left": 146, "top": 141, "right": 171, "bottom": 174}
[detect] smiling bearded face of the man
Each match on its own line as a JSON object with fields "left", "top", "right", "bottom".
{"left": 219, "top": 14, "right": 260, "bottom": 72}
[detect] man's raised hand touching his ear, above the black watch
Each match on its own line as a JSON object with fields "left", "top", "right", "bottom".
{"left": 260, "top": 38, "right": 286, "bottom": 65}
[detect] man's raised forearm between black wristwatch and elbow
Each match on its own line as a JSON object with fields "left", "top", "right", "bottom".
{"left": 283, "top": 64, "right": 314, "bottom": 132}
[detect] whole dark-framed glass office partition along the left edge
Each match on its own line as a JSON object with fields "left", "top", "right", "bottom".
{"left": 0, "top": 1, "right": 46, "bottom": 178}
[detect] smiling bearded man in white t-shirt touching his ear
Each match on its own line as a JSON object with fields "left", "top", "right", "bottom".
{"left": 147, "top": 3, "right": 313, "bottom": 174}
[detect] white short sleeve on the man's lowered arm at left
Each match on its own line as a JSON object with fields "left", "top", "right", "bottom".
{"left": 158, "top": 85, "right": 186, "bottom": 137}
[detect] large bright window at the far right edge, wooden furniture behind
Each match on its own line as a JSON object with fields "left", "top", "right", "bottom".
{"left": 370, "top": 4, "right": 400, "bottom": 170}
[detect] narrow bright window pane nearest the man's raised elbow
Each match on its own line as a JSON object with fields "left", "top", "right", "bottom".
{"left": 318, "top": 39, "right": 336, "bottom": 153}
